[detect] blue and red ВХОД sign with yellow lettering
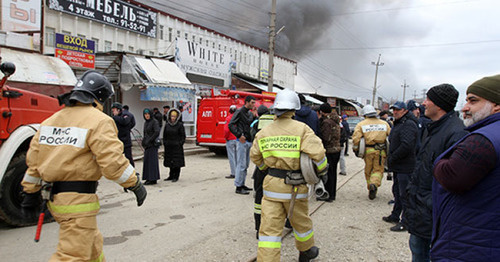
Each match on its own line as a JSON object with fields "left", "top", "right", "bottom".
{"left": 54, "top": 33, "right": 95, "bottom": 69}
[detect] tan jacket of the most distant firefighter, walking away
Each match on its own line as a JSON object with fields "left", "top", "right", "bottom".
{"left": 352, "top": 117, "right": 391, "bottom": 149}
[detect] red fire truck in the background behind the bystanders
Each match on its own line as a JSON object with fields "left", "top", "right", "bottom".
{"left": 196, "top": 90, "right": 274, "bottom": 154}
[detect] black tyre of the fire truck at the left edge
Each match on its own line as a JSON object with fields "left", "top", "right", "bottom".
{"left": 0, "top": 153, "right": 53, "bottom": 226}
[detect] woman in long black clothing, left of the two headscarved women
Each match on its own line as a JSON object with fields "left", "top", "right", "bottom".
{"left": 142, "top": 108, "right": 160, "bottom": 185}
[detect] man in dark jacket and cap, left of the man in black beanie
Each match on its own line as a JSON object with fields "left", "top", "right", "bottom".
{"left": 382, "top": 101, "right": 418, "bottom": 232}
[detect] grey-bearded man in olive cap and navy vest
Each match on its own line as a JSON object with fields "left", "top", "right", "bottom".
{"left": 431, "top": 75, "right": 500, "bottom": 261}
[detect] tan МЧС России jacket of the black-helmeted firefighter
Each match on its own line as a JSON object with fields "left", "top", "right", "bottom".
{"left": 22, "top": 104, "right": 137, "bottom": 193}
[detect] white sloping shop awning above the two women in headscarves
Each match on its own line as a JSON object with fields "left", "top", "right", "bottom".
{"left": 120, "top": 56, "right": 195, "bottom": 101}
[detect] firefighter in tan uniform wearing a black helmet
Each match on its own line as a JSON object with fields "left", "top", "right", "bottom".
{"left": 21, "top": 70, "right": 147, "bottom": 261}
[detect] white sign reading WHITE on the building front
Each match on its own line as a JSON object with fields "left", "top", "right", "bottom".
{"left": 175, "top": 38, "right": 231, "bottom": 87}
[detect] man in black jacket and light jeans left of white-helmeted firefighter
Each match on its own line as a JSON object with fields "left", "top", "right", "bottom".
{"left": 229, "top": 96, "right": 255, "bottom": 195}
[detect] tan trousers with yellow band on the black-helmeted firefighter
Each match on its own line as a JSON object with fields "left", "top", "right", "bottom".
{"left": 49, "top": 193, "right": 105, "bottom": 262}
